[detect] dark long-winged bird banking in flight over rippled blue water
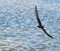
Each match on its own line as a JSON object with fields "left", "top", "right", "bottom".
{"left": 35, "top": 5, "right": 53, "bottom": 38}
